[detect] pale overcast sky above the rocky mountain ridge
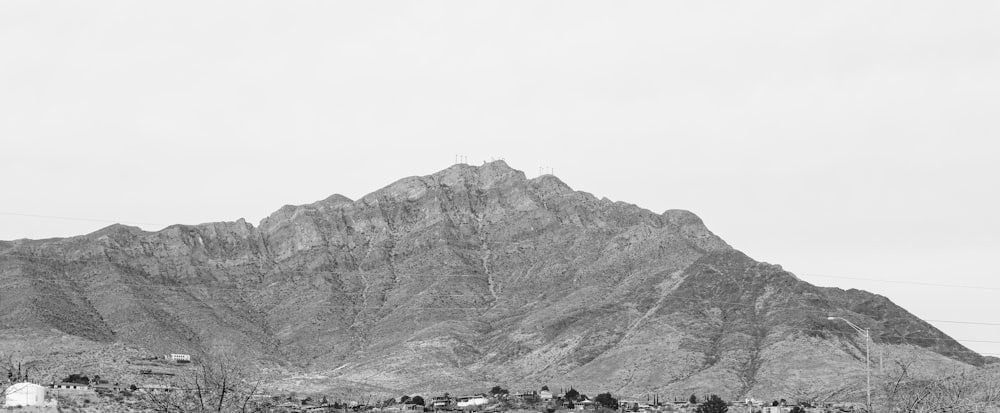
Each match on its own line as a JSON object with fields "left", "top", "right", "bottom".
{"left": 0, "top": 0, "right": 1000, "bottom": 355}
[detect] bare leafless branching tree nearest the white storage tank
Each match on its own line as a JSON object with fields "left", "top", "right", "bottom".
{"left": 143, "top": 353, "right": 262, "bottom": 413}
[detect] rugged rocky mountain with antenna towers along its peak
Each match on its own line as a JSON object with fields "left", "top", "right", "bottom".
{"left": 0, "top": 161, "right": 986, "bottom": 397}
